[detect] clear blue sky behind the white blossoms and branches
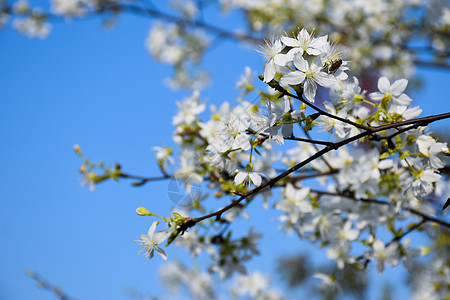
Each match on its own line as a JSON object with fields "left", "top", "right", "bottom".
{"left": 0, "top": 3, "right": 450, "bottom": 300}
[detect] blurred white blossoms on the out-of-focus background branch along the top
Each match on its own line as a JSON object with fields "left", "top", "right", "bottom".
{"left": 0, "top": 0, "right": 450, "bottom": 89}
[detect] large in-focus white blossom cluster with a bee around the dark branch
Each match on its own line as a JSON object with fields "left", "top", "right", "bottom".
{"left": 135, "top": 29, "right": 449, "bottom": 295}
